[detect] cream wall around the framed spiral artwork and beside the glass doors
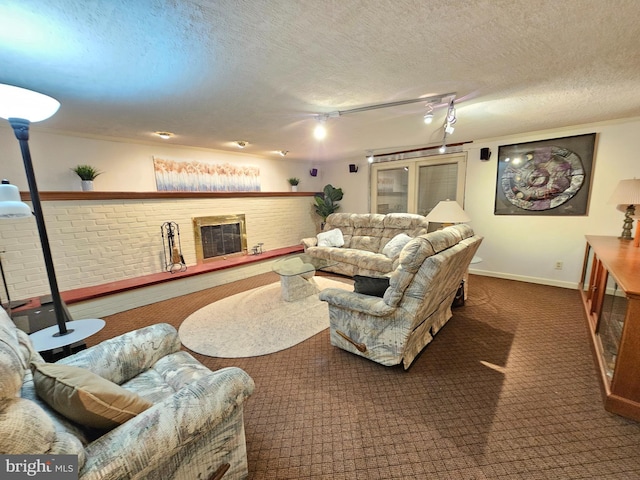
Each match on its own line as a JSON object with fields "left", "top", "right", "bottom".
{"left": 330, "top": 118, "right": 640, "bottom": 288}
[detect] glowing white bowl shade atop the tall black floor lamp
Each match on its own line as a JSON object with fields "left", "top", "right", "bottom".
{"left": 0, "top": 84, "right": 60, "bottom": 122}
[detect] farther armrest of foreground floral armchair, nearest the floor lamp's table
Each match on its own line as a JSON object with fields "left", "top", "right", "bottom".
{"left": 57, "top": 323, "right": 181, "bottom": 385}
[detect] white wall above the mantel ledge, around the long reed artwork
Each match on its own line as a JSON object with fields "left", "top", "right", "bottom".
{"left": 0, "top": 122, "right": 327, "bottom": 192}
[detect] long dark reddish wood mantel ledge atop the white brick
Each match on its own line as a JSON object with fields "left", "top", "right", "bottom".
{"left": 20, "top": 191, "right": 318, "bottom": 202}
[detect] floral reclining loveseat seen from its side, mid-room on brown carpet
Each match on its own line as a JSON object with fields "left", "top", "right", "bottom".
{"left": 320, "top": 224, "right": 482, "bottom": 369}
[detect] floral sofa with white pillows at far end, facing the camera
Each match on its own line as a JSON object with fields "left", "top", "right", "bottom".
{"left": 302, "top": 213, "right": 429, "bottom": 277}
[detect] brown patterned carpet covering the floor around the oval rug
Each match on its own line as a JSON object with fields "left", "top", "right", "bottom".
{"left": 89, "top": 273, "right": 640, "bottom": 480}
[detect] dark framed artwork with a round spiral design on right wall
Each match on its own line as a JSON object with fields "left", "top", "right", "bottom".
{"left": 494, "top": 133, "right": 596, "bottom": 216}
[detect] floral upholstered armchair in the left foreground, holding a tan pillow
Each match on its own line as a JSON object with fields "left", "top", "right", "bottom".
{"left": 0, "top": 309, "right": 254, "bottom": 480}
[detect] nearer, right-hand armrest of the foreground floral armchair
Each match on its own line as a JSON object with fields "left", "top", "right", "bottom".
{"left": 80, "top": 367, "right": 255, "bottom": 480}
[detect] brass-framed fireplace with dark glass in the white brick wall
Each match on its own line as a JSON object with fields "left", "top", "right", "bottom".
{"left": 192, "top": 214, "right": 247, "bottom": 263}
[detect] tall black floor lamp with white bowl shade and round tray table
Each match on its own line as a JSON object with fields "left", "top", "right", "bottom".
{"left": 0, "top": 84, "right": 104, "bottom": 351}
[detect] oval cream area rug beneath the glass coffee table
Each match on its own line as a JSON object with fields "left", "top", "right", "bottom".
{"left": 178, "top": 277, "right": 353, "bottom": 358}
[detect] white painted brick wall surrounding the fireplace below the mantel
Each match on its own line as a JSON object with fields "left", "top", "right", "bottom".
{"left": 0, "top": 196, "right": 319, "bottom": 300}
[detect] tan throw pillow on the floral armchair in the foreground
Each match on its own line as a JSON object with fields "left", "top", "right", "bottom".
{"left": 31, "top": 363, "right": 153, "bottom": 429}
